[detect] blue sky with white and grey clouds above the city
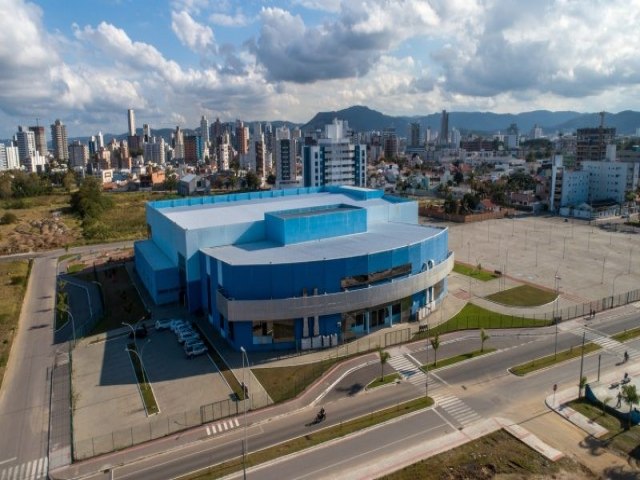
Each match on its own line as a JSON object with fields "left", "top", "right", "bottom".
{"left": 0, "top": 0, "right": 640, "bottom": 138}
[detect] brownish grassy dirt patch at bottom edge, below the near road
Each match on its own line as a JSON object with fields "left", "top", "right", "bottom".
{"left": 383, "top": 430, "right": 598, "bottom": 480}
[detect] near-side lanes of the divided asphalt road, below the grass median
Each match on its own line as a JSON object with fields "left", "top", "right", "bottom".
{"left": 219, "top": 340, "right": 640, "bottom": 480}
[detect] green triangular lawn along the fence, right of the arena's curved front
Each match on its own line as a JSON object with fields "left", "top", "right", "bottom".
{"left": 413, "top": 303, "right": 551, "bottom": 340}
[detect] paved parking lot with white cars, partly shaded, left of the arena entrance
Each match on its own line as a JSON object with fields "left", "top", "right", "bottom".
{"left": 72, "top": 322, "right": 232, "bottom": 458}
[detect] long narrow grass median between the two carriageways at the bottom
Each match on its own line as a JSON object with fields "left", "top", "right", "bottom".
{"left": 185, "top": 397, "right": 433, "bottom": 480}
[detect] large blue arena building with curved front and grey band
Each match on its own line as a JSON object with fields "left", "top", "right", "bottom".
{"left": 135, "top": 187, "right": 453, "bottom": 350}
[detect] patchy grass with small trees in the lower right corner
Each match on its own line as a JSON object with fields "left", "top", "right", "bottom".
{"left": 569, "top": 398, "right": 640, "bottom": 460}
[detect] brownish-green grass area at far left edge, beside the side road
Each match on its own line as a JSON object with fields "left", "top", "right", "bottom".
{"left": 0, "top": 260, "right": 31, "bottom": 392}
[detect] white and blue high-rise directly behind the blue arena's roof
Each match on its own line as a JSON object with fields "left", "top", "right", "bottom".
{"left": 303, "top": 119, "right": 367, "bottom": 187}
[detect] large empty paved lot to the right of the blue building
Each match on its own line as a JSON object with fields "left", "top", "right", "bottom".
{"left": 449, "top": 216, "right": 640, "bottom": 303}
